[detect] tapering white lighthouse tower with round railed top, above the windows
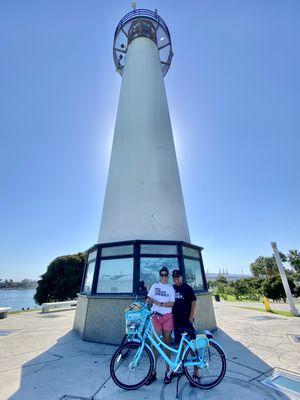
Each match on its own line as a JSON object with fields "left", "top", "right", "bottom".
{"left": 99, "top": 10, "right": 190, "bottom": 243}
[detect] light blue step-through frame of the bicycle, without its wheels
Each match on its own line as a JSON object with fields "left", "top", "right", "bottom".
{"left": 130, "top": 317, "right": 207, "bottom": 372}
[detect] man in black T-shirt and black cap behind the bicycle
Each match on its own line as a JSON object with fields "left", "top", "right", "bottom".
{"left": 172, "top": 269, "right": 200, "bottom": 386}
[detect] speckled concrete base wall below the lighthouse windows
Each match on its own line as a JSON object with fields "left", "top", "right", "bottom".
{"left": 73, "top": 293, "right": 217, "bottom": 344}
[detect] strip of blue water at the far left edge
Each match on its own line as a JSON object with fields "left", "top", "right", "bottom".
{"left": 0, "top": 289, "right": 39, "bottom": 311}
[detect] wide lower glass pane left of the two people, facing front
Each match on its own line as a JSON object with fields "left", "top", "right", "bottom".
{"left": 97, "top": 258, "right": 133, "bottom": 293}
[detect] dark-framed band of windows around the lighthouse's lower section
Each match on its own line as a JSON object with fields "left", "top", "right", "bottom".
{"left": 81, "top": 240, "right": 207, "bottom": 296}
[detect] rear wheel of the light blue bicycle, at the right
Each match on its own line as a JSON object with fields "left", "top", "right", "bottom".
{"left": 183, "top": 342, "right": 226, "bottom": 389}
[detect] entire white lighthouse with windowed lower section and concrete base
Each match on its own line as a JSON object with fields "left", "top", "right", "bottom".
{"left": 74, "top": 9, "right": 216, "bottom": 344}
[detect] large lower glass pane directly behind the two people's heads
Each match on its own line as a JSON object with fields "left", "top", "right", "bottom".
{"left": 140, "top": 257, "right": 179, "bottom": 294}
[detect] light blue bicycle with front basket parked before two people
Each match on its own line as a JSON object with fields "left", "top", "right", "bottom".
{"left": 110, "top": 301, "right": 226, "bottom": 390}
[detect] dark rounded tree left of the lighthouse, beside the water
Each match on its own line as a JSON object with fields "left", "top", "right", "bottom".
{"left": 34, "top": 253, "right": 85, "bottom": 304}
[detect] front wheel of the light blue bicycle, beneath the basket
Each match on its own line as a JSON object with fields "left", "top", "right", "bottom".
{"left": 110, "top": 342, "right": 154, "bottom": 390}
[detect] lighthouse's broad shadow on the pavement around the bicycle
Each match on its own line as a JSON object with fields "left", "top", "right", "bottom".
{"left": 9, "top": 329, "right": 290, "bottom": 400}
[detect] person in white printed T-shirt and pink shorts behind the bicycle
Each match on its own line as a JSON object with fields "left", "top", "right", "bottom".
{"left": 145, "top": 267, "right": 175, "bottom": 386}
